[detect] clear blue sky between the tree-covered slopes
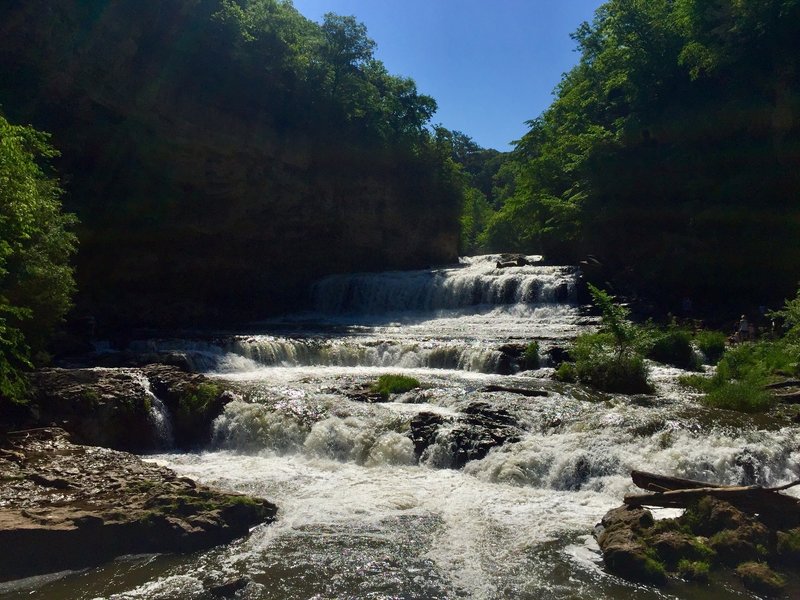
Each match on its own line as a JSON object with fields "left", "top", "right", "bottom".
{"left": 293, "top": 0, "right": 602, "bottom": 150}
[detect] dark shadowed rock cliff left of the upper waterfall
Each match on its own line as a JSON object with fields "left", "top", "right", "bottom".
{"left": 0, "top": 0, "right": 459, "bottom": 327}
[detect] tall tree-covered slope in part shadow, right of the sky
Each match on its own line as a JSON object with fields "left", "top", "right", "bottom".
{"left": 482, "top": 0, "right": 800, "bottom": 303}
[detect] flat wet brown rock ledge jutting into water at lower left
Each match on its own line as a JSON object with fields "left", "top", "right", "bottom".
{"left": 0, "top": 429, "right": 277, "bottom": 581}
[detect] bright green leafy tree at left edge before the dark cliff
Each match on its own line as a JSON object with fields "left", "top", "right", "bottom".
{"left": 0, "top": 115, "right": 75, "bottom": 402}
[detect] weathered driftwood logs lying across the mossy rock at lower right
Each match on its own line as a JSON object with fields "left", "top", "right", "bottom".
{"left": 623, "top": 471, "right": 800, "bottom": 521}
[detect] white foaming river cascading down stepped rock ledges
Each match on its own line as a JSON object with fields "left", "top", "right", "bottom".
{"left": 3, "top": 256, "right": 800, "bottom": 600}
